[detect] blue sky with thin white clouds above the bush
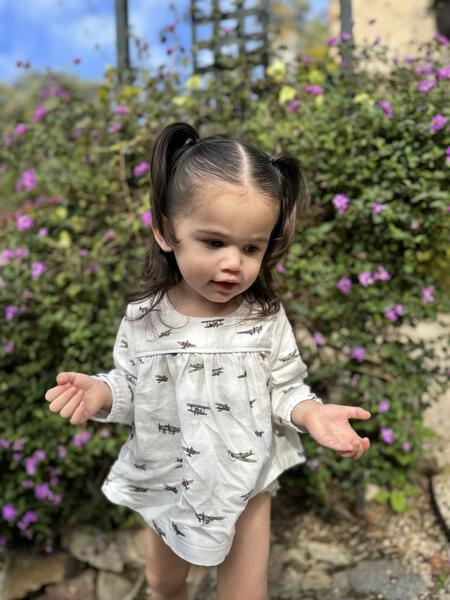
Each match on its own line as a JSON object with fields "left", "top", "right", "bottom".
{"left": 0, "top": 0, "right": 328, "bottom": 84}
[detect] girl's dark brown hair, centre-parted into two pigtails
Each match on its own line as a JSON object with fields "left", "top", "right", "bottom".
{"left": 126, "top": 123, "right": 308, "bottom": 317}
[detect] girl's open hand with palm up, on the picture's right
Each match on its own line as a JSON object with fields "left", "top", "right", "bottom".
{"left": 302, "top": 404, "right": 371, "bottom": 460}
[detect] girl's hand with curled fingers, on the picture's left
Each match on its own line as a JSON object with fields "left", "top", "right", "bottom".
{"left": 45, "top": 373, "right": 112, "bottom": 425}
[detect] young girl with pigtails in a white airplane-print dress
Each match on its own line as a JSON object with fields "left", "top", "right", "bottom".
{"left": 45, "top": 123, "right": 370, "bottom": 600}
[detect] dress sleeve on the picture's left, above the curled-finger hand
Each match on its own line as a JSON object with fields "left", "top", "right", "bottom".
{"left": 91, "top": 316, "right": 137, "bottom": 425}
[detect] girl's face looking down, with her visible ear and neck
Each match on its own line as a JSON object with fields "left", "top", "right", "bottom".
{"left": 153, "top": 182, "right": 279, "bottom": 316}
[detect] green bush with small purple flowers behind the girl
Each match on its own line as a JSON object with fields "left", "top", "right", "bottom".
{"left": 0, "top": 34, "right": 450, "bottom": 551}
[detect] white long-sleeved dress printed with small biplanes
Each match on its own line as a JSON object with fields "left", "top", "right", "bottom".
{"left": 92, "top": 297, "right": 320, "bottom": 565}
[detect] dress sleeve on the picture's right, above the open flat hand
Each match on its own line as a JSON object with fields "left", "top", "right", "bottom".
{"left": 271, "top": 306, "right": 322, "bottom": 433}
